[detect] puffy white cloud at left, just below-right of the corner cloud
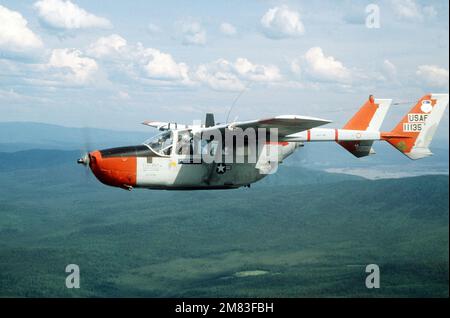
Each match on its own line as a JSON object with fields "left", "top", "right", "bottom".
{"left": 47, "top": 49, "right": 98, "bottom": 84}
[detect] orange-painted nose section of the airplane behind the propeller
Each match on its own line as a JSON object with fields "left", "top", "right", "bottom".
{"left": 88, "top": 148, "right": 136, "bottom": 190}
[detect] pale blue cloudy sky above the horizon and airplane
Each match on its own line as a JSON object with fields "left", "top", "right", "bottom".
{"left": 0, "top": 0, "right": 449, "bottom": 142}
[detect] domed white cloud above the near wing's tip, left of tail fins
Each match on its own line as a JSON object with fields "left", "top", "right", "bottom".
{"left": 298, "top": 47, "right": 351, "bottom": 83}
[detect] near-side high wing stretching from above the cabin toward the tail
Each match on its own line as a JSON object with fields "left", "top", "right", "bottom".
{"left": 202, "top": 115, "right": 331, "bottom": 137}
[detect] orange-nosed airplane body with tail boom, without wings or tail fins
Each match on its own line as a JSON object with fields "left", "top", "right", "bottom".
{"left": 89, "top": 129, "right": 380, "bottom": 190}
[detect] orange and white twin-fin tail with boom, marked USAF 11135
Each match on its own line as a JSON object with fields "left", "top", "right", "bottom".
{"left": 282, "top": 94, "right": 449, "bottom": 160}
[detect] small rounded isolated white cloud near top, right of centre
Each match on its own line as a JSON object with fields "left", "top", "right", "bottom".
{"left": 261, "top": 5, "right": 305, "bottom": 39}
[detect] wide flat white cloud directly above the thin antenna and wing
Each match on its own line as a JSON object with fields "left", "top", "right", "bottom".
{"left": 195, "top": 58, "right": 281, "bottom": 90}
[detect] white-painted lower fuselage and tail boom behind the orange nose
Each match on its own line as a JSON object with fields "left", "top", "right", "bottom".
{"left": 135, "top": 128, "right": 380, "bottom": 189}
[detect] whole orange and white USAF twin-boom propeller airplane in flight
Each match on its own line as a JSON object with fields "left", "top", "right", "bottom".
{"left": 77, "top": 94, "right": 449, "bottom": 190}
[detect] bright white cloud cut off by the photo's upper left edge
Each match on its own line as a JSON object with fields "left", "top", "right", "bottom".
{"left": 0, "top": 5, "right": 43, "bottom": 52}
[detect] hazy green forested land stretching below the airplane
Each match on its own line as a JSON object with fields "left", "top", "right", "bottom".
{"left": 0, "top": 150, "right": 449, "bottom": 297}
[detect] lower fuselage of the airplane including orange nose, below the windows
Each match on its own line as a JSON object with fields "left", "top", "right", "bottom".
{"left": 89, "top": 142, "right": 299, "bottom": 190}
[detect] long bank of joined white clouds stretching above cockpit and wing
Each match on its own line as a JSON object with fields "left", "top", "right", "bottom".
{"left": 87, "top": 34, "right": 281, "bottom": 90}
